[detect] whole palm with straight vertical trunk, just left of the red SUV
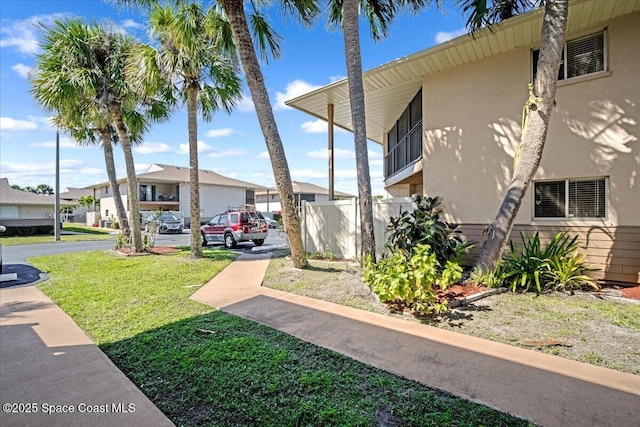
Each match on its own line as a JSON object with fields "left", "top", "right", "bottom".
{"left": 140, "top": 3, "right": 242, "bottom": 258}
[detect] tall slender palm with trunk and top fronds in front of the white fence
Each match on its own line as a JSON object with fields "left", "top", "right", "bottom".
{"left": 329, "top": 0, "right": 437, "bottom": 262}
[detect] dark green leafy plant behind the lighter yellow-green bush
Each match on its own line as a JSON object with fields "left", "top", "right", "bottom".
{"left": 386, "top": 195, "right": 474, "bottom": 265}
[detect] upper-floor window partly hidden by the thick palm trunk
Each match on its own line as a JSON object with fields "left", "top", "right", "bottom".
{"left": 533, "top": 30, "right": 607, "bottom": 80}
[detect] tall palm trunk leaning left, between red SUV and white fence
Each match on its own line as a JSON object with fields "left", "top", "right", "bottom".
{"left": 219, "top": 0, "right": 309, "bottom": 268}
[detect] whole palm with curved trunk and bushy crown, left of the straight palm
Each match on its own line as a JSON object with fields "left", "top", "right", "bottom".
{"left": 31, "top": 19, "right": 167, "bottom": 252}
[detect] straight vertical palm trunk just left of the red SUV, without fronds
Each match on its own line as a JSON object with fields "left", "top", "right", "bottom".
{"left": 187, "top": 81, "right": 202, "bottom": 258}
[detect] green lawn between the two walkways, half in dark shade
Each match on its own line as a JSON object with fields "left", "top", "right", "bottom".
{"left": 30, "top": 249, "right": 527, "bottom": 426}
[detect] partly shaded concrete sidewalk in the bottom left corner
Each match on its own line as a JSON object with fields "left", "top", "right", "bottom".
{"left": 0, "top": 286, "right": 173, "bottom": 426}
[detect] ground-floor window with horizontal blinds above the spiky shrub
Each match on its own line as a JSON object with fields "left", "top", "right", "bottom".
{"left": 534, "top": 178, "right": 607, "bottom": 218}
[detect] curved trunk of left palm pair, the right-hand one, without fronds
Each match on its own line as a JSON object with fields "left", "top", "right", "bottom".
{"left": 109, "top": 103, "right": 144, "bottom": 252}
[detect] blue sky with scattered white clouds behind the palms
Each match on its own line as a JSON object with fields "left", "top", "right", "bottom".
{"left": 0, "top": 0, "right": 464, "bottom": 194}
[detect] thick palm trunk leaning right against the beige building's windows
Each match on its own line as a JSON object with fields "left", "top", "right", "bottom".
{"left": 475, "top": 0, "right": 568, "bottom": 271}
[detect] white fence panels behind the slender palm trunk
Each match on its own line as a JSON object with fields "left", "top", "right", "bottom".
{"left": 301, "top": 197, "right": 414, "bottom": 259}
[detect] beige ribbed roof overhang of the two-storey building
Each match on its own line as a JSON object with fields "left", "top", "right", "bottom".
{"left": 286, "top": 0, "right": 640, "bottom": 144}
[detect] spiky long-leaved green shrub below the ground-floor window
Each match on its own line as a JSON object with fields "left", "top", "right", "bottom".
{"left": 504, "top": 232, "right": 598, "bottom": 295}
